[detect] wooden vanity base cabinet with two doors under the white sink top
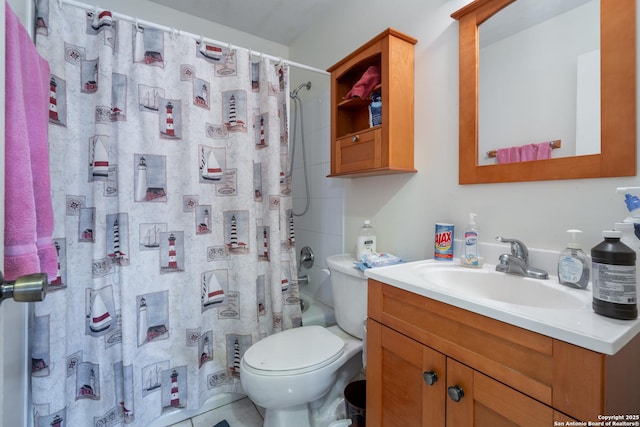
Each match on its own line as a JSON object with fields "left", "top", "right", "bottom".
{"left": 366, "top": 279, "right": 640, "bottom": 427}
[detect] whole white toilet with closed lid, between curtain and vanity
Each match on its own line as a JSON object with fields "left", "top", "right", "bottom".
{"left": 240, "top": 254, "right": 367, "bottom": 427}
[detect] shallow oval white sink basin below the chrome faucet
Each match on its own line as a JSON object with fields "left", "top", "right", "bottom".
{"left": 415, "top": 263, "right": 585, "bottom": 310}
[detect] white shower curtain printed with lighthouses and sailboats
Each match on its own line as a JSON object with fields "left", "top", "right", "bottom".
{"left": 31, "top": 0, "right": 300, "bottom": 427}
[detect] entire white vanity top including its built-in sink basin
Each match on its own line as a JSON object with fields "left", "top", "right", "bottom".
{"left": 365, "top": 260, "right": 640, "bottom": 354}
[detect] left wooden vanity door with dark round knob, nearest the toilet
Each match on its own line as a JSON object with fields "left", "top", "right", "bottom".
{"left": 367, "top": 320, "right": 446, "bottom": 427}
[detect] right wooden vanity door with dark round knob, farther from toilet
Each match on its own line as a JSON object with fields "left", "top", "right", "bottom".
{"left": 446, "top": 359, "right": 554, "bottom": 427}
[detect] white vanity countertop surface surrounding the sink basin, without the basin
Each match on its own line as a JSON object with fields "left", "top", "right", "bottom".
{"left": 365, "top": 260, "right": 640, "bottom": 355}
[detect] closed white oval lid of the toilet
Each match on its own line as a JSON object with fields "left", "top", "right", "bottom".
{"left": 243, "top": 326, "right": 344, "bottom": 374}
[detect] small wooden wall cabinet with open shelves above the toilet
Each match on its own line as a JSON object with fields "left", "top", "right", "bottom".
{"left": 327, "top": 28, "right": 417, "bottom": 177}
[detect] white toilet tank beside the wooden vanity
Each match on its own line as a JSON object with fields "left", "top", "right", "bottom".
{"left": 327, "top": 254, "right": 367, "bottom": 339}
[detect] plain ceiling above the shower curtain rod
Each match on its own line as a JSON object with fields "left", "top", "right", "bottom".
{"left": 150, "top": 0, "right": 338, "bottom": 46}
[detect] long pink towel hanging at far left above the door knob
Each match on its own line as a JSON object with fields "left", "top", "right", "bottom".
{"left": 4, "top": 3, "right": 57, "bottom": 280}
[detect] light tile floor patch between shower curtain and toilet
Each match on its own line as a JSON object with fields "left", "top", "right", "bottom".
{"left": 170, "top": 397, "right": 262, "bottom": 427}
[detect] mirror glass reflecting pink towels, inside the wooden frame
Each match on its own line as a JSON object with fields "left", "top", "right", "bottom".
{"left": 477, "top": 0, "right": 600, "bottom": 165}
